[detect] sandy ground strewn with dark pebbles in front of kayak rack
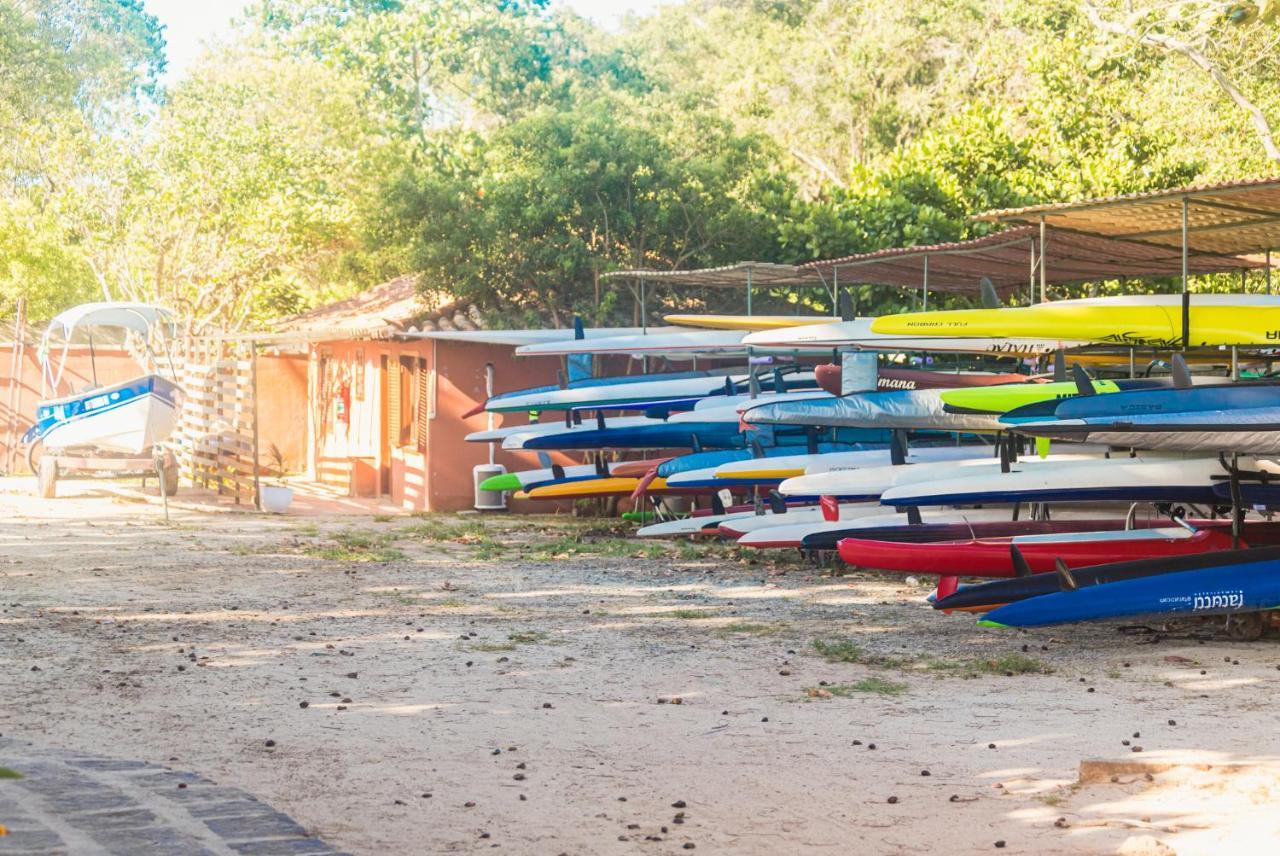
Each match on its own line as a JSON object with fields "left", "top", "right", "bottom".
{"left": 0, "top": 481, "right": 1280, "bottom": 855}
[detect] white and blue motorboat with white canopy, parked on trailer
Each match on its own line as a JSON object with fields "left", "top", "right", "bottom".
{"left": 22, "top": 302, "right": 182, "bottom": 471}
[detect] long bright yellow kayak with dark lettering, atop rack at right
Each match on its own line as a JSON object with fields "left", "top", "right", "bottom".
{"left": 872, "top": 294, "right": 1280, "bottom": 348}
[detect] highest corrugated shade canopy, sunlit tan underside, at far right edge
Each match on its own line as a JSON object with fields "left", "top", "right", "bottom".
{"left": 977, "top": 172, "right": 1280, "bottom": 256}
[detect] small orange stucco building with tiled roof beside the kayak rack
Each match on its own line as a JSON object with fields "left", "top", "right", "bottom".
{"left": 286, "top": 276, "right": 573, "bottom": 512}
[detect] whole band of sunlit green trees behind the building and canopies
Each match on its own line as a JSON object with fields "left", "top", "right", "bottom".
{"left": 0, "top": 0, "right": 1280, "bottom": 328}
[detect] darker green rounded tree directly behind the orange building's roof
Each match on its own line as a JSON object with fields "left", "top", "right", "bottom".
{"left": 396, "top": 97, "right": 790, "bottom": 324}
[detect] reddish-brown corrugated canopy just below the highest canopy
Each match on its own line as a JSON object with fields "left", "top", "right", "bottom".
{"left": 804, "top": 225, "right": 1262, "bottom": 294}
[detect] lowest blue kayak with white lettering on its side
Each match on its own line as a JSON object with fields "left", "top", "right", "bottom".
{"left": 978, "top": 548, "right": 1280, "bottom": 627}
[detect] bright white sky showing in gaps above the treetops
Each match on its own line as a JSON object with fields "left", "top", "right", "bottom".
{"left": 146, "top": 0, "right": 659, "bottom": 83}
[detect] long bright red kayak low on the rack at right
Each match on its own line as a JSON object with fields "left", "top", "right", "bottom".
{"left": 836, "top": 521, "right": 1280, "bottom": 577}
